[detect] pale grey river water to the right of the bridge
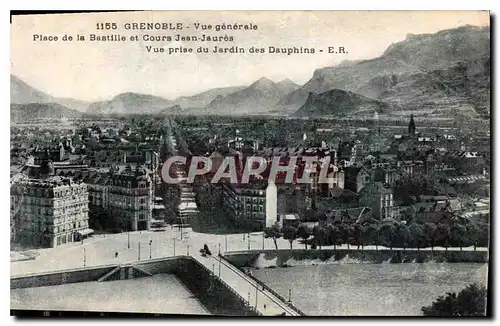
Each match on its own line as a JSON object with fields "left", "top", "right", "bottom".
{"left": 252, "top": 263, "right": 488, "bottom": 316}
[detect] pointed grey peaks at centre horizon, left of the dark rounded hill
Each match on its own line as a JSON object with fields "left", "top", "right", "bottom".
{"left": 205, "top": 77, "right": 299, "bottom": 115}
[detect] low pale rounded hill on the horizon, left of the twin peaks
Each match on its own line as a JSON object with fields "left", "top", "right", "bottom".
{"left": 87, "top": 93, "right": 173, "bottom": 115}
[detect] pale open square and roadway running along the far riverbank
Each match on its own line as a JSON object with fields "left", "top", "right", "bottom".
{"left": 10, "top": 228, "right": 488, "bottom": 275}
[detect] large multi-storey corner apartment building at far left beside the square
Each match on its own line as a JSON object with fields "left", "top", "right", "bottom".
{"left": 11, "top": 177, "right": 93, "bottom": 247}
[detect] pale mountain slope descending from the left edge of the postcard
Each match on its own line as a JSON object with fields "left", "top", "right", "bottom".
{"left": 10, "top": 75, "right": 90, "bottom": 112}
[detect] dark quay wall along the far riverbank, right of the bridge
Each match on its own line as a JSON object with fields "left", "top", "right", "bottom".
{"left": 224, "top": 249, "right": 488, "bottom": 268}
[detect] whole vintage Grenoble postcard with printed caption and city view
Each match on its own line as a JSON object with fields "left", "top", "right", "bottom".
{"left": 10, "top": 11, "right": 492, "bottom": 317}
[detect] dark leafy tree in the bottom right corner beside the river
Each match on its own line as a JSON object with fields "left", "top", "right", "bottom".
{"left": 422, "top": 284, "right": 487, "bottom": 317}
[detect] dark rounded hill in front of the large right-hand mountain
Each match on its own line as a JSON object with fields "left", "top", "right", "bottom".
{"left": 294, "top": 89, "right": 389, "bottom": 117}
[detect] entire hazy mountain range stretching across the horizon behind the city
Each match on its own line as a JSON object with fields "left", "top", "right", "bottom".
{"left": 11, "top": 26, "right": 491, "bottom": 116}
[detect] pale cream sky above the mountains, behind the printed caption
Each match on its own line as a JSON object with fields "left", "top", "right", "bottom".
{"left": 10, "top": 11, "right": 489, "bottom": 101}
